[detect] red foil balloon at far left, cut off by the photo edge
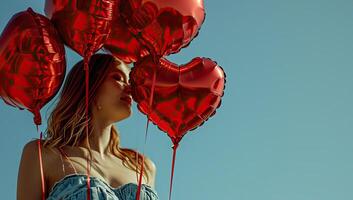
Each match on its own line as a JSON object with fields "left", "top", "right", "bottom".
{"left": 0, "top": 8, "right": 66, "bottom": 125}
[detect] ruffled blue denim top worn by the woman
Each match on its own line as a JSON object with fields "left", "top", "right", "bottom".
{"left": 47, "top": 174, "right": 159, "bottom": 200}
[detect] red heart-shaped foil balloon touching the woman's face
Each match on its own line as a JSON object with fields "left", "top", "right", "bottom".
{"left": 130, "top": 56, "right": 225, "bottom": 144}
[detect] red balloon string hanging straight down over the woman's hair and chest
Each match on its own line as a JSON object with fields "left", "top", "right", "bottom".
{"left": 83, "top": 54, "right": 91, "bottom": 200}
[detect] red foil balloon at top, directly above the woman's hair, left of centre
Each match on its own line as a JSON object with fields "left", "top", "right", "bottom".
{"left": 45, "top": 0, "right": 117, "bottom": 57}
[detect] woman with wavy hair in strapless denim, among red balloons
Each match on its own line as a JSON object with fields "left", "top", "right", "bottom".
{"left": 17, "top": 54, "right": 158, "bottom": 200}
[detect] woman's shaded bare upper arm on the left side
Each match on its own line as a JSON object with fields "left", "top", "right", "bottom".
{"left": 17, "top": 140, "right": 42, "bottom": 200}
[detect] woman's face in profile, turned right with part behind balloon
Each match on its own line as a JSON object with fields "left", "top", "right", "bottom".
{"left": 94, "top": 61, "right": 132, "bottom": 123}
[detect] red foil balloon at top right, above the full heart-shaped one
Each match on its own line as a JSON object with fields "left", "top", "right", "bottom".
{"left": 120, "top": 0, "right": 205, "bottom": 57}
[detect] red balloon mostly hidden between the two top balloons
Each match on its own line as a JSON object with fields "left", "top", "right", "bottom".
{"left": 104, "top": 1, "right": 148, "bottom": 63}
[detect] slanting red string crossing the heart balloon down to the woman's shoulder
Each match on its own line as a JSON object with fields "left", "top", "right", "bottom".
{"left": 136, "top": 56, "right": 159, "bottom": 200}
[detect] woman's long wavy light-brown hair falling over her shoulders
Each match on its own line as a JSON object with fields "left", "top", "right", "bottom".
{"left": 43, "top": 54, "right": 151, "bottom": 181}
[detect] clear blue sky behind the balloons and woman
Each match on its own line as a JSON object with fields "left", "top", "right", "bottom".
{"left": 0, "top": 0, "right": 353, "bottom": 200}
